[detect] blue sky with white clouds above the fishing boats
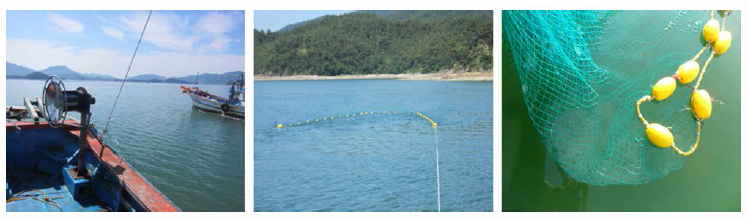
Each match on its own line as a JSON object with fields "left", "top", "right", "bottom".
{"left": 6, "top": 11, "right": 245, "bottom": 78}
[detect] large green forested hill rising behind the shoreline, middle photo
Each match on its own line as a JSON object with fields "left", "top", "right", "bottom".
{"left": 253, "top": 11, "right": 493, "bottom": 76}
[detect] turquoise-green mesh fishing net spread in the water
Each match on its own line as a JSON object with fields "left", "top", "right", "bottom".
{"left": 502, "top": 11, "right": 730, "bottom": 185}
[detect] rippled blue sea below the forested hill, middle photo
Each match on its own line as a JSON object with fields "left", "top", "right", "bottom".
{"left": 254, "top": 80, "right": 494, "bottom": 211}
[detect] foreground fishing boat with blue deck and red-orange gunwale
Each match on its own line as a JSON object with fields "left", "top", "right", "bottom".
{"left": 6, "top": 121, "right": 179, "bottom": 212}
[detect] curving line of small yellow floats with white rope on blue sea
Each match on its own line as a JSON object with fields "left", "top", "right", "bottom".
{"left": 276, "top": 111, "right": 442, "bottom": 212}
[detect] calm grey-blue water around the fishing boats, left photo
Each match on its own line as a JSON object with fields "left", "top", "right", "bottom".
{"left": 5, "top": 80, "right": 245, "bottom": 211}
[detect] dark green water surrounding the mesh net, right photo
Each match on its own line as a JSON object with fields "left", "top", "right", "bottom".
{"left": 502, "top": 11, "right": 741, "bottom": 211}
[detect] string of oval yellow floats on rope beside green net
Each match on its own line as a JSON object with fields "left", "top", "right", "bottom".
{"left": 635, "top": 10, "right": 731, "bottom": 156}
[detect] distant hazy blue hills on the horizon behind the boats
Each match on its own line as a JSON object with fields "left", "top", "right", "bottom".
{"left": 5, "top": 61, "right": 244, "bottom": 85}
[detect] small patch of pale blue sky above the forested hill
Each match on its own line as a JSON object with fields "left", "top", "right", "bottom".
{"left": 254, "top": 10, "right": 353, "bottom": 31}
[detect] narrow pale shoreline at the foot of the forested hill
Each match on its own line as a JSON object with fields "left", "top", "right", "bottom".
{"left": 253, "top": 72, "right": 494, "bottom": 81}
